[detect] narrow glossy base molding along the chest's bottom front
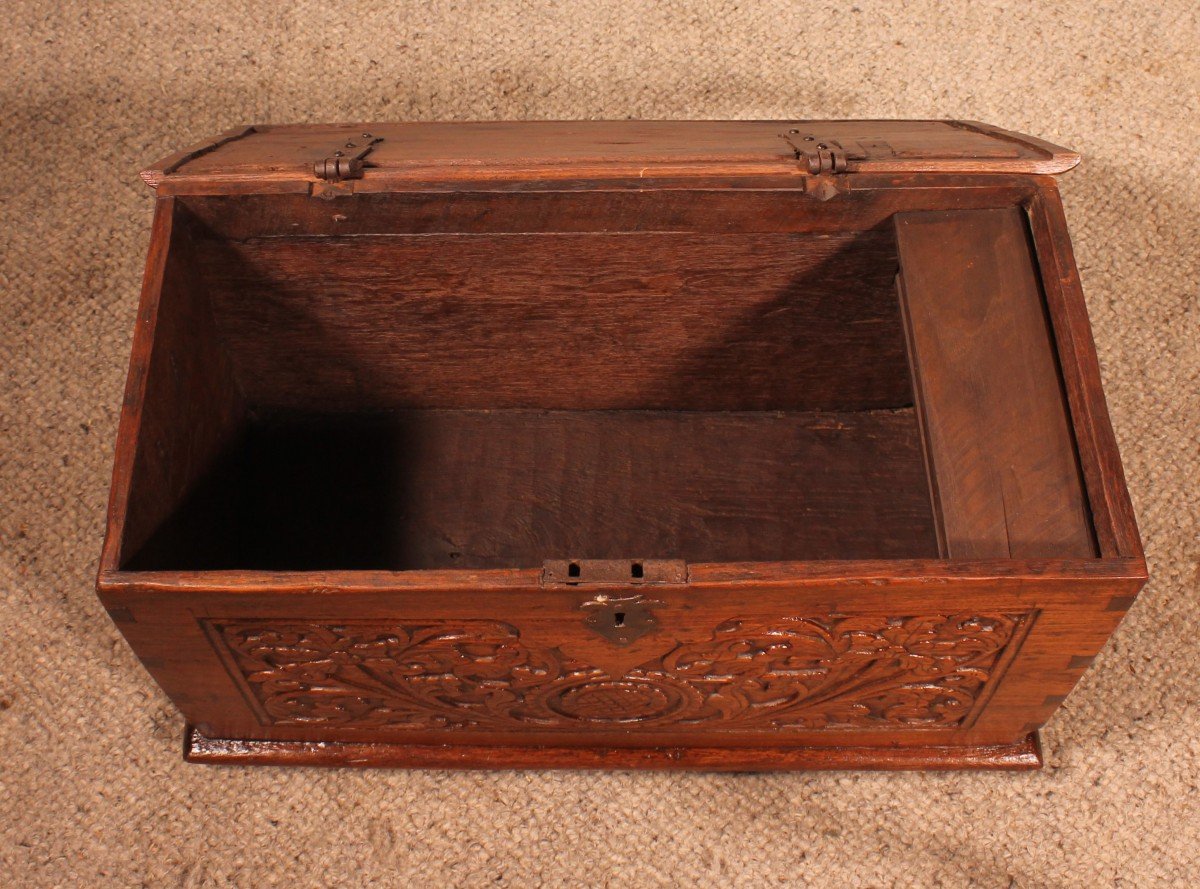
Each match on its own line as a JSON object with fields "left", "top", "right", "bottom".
{"left": 184, "top": 726, "right": 1042, "bottom": 771}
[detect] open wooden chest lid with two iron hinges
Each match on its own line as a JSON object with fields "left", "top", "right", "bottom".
{"left": 142, "top": 120, "right": 1079, "bottom": 193}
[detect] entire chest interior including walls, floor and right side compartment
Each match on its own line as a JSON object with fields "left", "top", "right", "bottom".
{"left": 121, "top": 190, "right": 1094, "bottom": 570}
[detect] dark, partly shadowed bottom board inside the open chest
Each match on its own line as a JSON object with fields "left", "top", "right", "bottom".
{"left": 128, "top": 409, "right": 937, "bottom": 570}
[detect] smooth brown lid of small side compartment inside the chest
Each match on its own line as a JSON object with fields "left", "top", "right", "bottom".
{"left": 895, "top": 208, "right": 1097, "bottom": 558}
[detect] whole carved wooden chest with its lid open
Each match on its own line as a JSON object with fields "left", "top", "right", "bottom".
{"left": 98, "top": 121, "right": 1146, "bottom": 769}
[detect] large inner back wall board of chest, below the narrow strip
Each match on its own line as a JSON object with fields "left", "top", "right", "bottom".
{"left": 196, "top": 225, "right": 912, "bottom": 410}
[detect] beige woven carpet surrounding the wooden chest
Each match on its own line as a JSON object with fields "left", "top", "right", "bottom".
{"left": 0, "top": 0, "right": 1200, "bottom": 887}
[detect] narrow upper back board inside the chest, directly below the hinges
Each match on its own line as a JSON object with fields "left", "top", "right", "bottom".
{"left": 178, "top": 174, "right": 1054, "bottom": 242}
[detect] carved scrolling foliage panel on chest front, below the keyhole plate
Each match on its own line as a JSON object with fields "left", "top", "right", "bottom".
{"left": 206, "top": 614, "right": 1025, "bottom": 733}
